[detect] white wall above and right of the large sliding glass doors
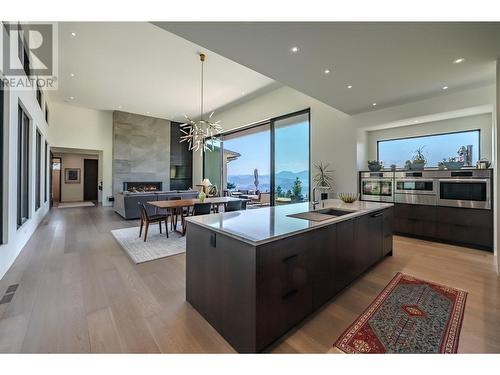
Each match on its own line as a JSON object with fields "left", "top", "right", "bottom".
{"left": 193, "top": 87, "right": 357, "bottom": 195}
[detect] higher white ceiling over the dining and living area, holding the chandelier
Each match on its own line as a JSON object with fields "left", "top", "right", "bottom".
{"left": 49, "top": 22, "right": 277, "bottom": 121}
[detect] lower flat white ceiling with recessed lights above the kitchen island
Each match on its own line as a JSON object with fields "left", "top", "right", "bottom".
{"left": 155, "top": 22, "right": 500, "bottom": 114}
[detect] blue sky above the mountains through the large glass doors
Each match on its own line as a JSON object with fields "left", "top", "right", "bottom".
{"left": 224, "top": 122, "right": 309, "bottom": 175}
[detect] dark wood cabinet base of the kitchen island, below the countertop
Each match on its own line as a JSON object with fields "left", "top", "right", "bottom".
{"left": 186, "top": 207, "right": 392, "bottom": 352}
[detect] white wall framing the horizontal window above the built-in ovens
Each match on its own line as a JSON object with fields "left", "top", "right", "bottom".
{"left": 366, "top": 113, "right": 493, "bottom": 160}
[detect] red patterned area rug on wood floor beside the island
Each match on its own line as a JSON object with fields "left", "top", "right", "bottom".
{"left": 335, "top": 272, "right": 467, "bottom": 354}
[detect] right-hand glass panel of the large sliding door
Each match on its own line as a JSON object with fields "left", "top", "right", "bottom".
{"left": 272, "top": 111, "right": 310, "bottom": 205}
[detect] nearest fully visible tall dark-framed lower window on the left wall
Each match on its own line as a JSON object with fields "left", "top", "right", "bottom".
{"left": 17, "top": 106, "right": 30, "bottom": 228}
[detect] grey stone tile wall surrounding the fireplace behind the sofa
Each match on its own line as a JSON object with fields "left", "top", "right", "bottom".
{"left": 113, "top": 111, "right": 170, "bottom": 194}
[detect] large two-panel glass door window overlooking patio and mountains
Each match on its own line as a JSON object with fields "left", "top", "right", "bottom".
{"left": 203, "top": 110, "right": 310, "bottom": 206}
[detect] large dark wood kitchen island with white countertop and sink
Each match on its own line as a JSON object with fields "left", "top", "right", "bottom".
{"left": 186, "top": 199, "right": 392, "bottom": 353}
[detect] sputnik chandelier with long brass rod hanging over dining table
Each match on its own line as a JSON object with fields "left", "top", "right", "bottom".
{"left": 180, "top": 53, "right": 223, "bottom": 152}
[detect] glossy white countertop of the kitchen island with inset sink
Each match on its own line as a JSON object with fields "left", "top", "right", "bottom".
{"left": 186, "top": 199, "right": 393, "bottom": 246}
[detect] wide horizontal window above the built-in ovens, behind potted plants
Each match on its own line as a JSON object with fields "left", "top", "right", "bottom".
{"left": 377, "top": 130, "right": 480, "bottom": 168}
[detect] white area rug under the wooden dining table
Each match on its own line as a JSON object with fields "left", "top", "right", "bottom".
{"left": 111, "top": 224, "right": 186, "bottom": 264}
